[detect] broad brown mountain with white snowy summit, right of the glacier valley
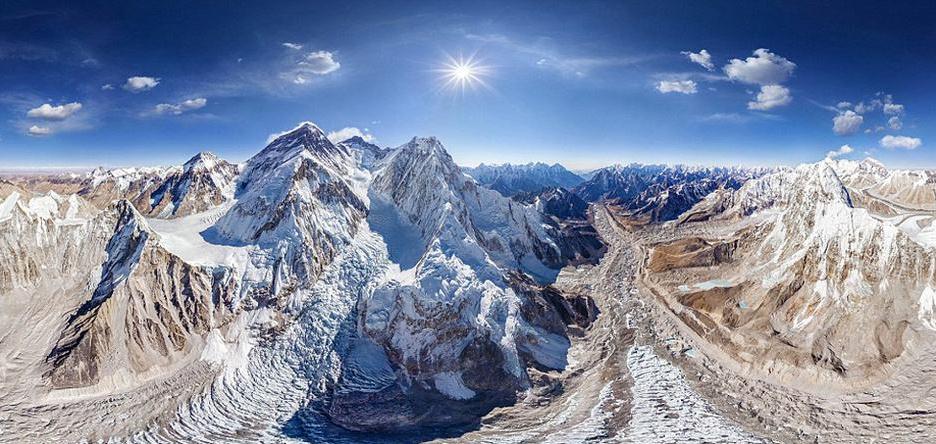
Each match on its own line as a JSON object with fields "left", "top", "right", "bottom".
{"left": 649, "top": 160, "right": 936, "bottom": 387}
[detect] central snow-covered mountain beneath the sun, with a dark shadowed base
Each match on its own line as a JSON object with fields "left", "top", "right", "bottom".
{"left": 332, "top": 138, "right": 589, "bottom": 429}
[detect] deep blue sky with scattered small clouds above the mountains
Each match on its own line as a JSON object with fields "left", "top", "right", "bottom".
{"left": 0, "top": 0, "right": 936, "bottom": 168}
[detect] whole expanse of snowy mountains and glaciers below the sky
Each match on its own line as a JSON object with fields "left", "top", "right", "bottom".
{"left": 0, "top": 122, "right": 936, "bottom": 442}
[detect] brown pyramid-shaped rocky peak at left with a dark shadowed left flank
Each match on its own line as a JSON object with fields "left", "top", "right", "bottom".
{"left": 46, "top": 201, "right": 237, "bottom": 388}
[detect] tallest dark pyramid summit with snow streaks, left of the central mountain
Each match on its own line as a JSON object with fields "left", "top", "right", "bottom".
{"left": 209, "top": 123, "right": 367, "bottom": 288}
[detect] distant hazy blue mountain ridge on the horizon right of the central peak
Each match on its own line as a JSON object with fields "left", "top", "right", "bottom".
{"left": 463, "top": 163, "right": 584, "bottom": 197}
